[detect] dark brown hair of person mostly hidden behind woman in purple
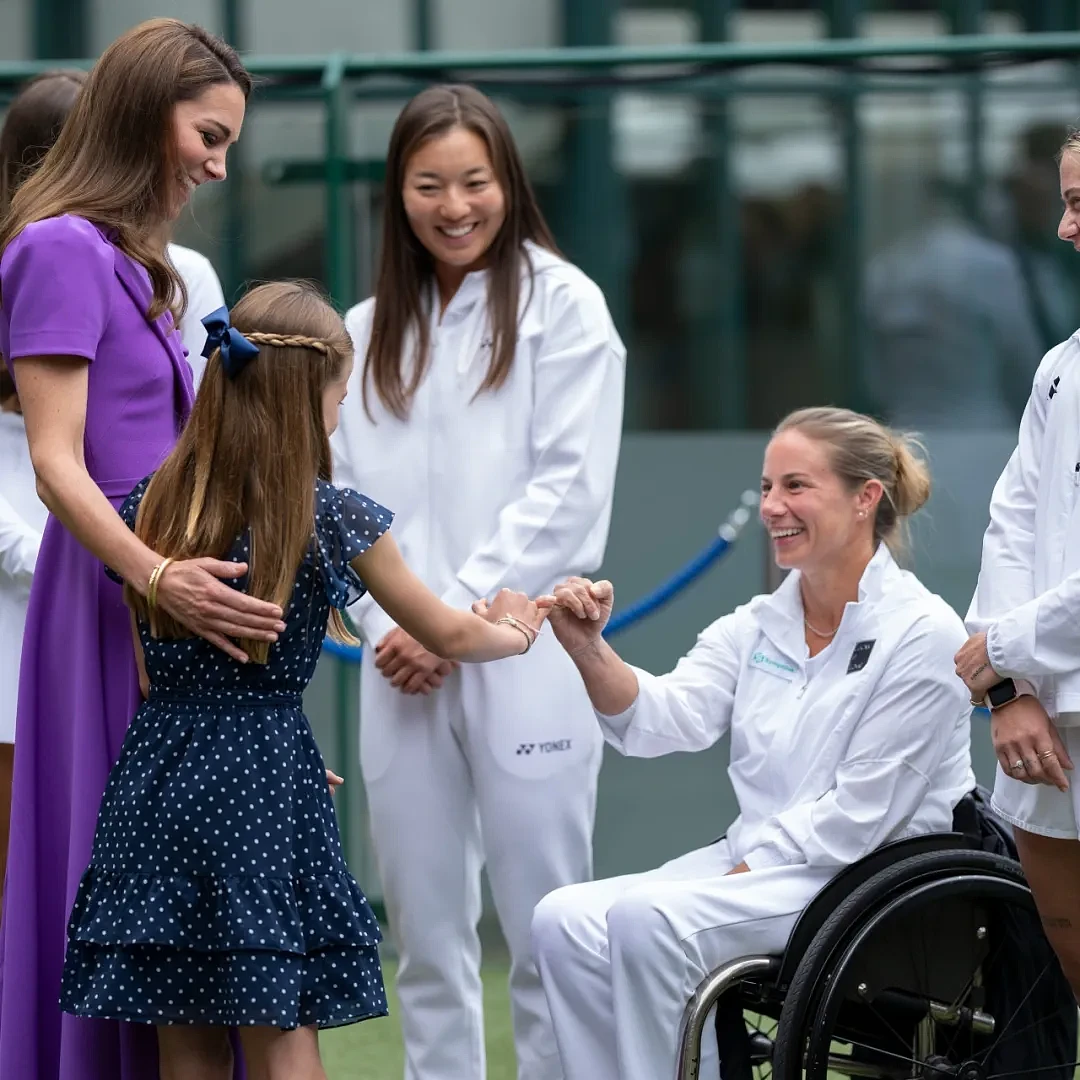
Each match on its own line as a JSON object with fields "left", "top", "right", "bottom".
{"left": 0, "top": 68, "right": 86, "bottom": 410}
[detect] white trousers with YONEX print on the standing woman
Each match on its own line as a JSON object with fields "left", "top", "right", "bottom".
{"left": 361, "top": 631, "right": 603, "bottom": 1080}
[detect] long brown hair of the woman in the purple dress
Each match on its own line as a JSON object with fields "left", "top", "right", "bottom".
{"left": 0, "top": 18, "right": 252, "bottom": 320}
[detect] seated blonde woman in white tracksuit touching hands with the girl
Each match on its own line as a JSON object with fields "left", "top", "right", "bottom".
{"left": 532, "top": 408, "right": 975, "bottom": 1080}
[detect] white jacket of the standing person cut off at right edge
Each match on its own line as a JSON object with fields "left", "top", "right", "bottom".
{"left": 967, "top": 332, "right": 1080, "bottom": 717}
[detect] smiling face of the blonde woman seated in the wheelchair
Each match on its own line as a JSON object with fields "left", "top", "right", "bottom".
{"left": 761, "top": 429, "right": 882, "bottom": 571}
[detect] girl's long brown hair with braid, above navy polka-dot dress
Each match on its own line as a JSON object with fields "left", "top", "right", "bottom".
{"left": 124, "top": 282, "right": 352, "bottom": 662}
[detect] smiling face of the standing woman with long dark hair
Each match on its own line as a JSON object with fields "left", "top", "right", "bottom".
{"left": 402, "top": 127, "right": 507, "bottom": 275}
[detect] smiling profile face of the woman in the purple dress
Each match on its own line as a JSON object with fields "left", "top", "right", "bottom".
{"left": 170, "top": 82, "right": 246, "bottom": 218}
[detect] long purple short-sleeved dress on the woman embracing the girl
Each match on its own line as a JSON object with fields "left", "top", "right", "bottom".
{"left": 0, "top": 215, "right": 212, "bottom": 1080}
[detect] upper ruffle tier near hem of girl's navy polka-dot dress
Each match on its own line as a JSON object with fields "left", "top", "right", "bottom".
{"left": 68, "top": 866, "right": 382, "bottom": 956}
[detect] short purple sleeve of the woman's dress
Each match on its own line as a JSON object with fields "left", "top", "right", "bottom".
{"left": 0, "top": 215, "right": 114, "bottom": 360}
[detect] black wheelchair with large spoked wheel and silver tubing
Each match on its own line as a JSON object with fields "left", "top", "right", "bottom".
{"left": 676, "top": 797, "right": 1078, "bottom": 1080}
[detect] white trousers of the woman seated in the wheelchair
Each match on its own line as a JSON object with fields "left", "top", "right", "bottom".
{"left": 532, "top": 840, "right": 835, "bottom": 1080}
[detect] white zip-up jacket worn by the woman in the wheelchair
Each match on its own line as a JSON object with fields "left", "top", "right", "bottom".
{"left": 597, "top": 544, "right": 975, "bottom": 870}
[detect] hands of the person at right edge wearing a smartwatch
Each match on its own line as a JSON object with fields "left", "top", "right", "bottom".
{"left": 953, "top": 633, "right": 1072, "bottom": 792}
